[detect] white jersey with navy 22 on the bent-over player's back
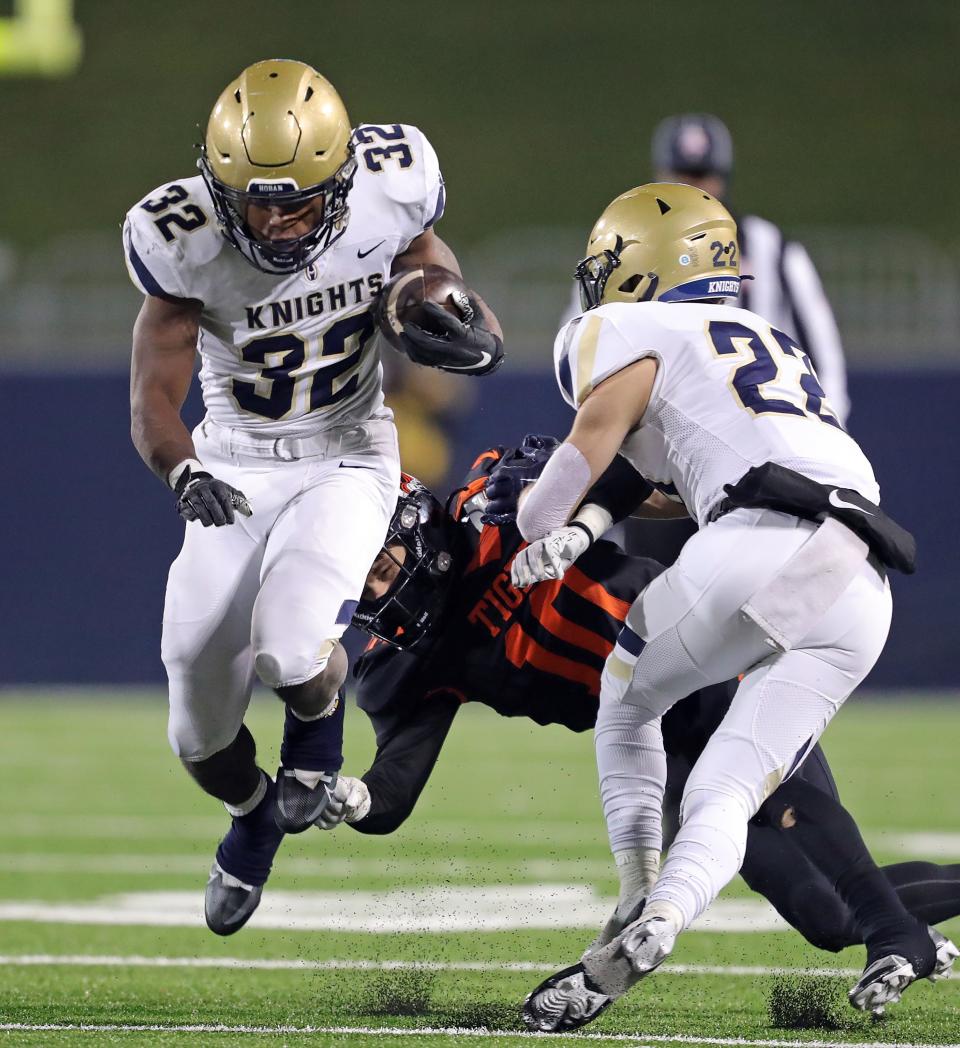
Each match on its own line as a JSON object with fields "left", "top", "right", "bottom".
{"left": 553, "top": 302, "right": 879, "bottom": 524}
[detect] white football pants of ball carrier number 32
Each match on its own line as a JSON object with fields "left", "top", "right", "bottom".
{"left": 161, "top": 419, "right": 400, "bottom": 761}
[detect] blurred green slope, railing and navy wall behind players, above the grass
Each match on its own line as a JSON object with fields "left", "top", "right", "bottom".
{"left": 0, "top": 0, "right": 960, "bottom": 687}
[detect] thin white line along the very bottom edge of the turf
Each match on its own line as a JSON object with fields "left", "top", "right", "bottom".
{"left": 0, "top": 1023, "right": 960, "bottom": 1048}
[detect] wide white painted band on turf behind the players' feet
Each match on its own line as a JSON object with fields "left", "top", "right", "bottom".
{"left": 0, "top": 883, "right": 788, "bottom": 934}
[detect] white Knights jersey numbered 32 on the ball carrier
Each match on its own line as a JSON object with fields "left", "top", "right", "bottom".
{"left": 124, "top": 124, "right": 444, "bottom": 437}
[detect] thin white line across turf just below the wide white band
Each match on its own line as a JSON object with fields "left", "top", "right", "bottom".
{"left": 0, "top": 954, "right": 860, "bottom": 978}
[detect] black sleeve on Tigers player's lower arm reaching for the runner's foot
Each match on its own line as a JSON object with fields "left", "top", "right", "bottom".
{"left": 351, "top": 693, "right": 460, "bottom": 834}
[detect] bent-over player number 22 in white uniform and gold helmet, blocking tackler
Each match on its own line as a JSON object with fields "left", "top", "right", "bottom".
{"left": 512, "top": 183, "right": 936, "bottom": 1030}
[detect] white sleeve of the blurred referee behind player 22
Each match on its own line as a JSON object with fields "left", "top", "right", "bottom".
{"left": 781, "top": 241, "right": 850, "bottom": 425}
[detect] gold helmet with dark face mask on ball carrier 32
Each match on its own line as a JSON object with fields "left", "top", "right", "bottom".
{"left": 199, "top": 59, "right": 356, "bottom": 274}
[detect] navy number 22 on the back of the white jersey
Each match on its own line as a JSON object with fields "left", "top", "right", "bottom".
{"left": 706, "top": 321, "right": 843, "bottom": 429}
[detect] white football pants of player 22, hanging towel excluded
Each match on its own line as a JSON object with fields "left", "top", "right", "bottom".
{"left": 595, "top": 509, "right": 892, "bottom": 926}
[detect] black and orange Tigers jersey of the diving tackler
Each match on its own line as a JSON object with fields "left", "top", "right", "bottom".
{"left": 355, "top": 447, "right": 662, "bottom": 740}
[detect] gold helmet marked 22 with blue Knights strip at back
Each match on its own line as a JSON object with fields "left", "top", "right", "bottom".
{"left": 573, "top": 182, "right": 740, "bottom": 310}
